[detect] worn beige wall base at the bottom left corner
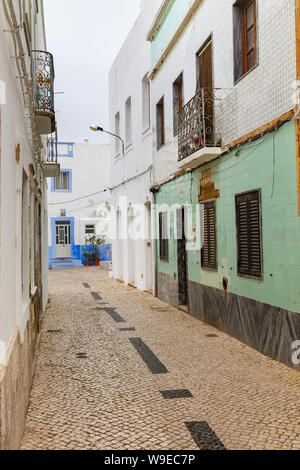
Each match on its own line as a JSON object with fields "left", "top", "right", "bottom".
{"left": 0, "top": 314, "right": 38, "bottom": 450}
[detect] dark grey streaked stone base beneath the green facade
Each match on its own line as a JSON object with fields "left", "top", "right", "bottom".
{"left": 157, "top": 273, "right": 300, "bottom": 371}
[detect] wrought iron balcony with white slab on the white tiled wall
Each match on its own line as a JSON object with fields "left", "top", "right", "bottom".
{"left": 178, "top": 88, "right": 221, "bottom": 168}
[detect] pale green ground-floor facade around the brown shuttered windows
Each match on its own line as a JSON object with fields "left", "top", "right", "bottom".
{"left": 156, "top": 121, "right": 300, "bottom": 312}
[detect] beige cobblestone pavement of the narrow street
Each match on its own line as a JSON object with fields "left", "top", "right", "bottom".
{"left": 21, "top": 268, "right": 300, "bottom": 450}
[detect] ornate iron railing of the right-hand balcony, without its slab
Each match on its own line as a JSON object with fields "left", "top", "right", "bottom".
{"left": 178, "top": 88, "right": 220, "bottom": 161}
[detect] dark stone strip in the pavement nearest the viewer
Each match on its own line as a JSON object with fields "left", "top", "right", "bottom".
{"left": 185, "top": 421, "right": 226, "bottom": 450}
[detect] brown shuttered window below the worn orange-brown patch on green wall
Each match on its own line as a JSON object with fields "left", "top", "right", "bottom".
{"left": 201, "top": 201, "right": 218, "bottom": 270}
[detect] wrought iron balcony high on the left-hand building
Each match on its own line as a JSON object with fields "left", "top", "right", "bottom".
{"left": 32, "top": 51, "right": 55, "bottom": 134}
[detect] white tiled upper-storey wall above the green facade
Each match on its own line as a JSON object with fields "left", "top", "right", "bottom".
{"left": 151, "top": 0, "right": 296, "bottom": 182}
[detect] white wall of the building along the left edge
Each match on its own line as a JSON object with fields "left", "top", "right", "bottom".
{"left": 0, "top": 1, "right": 48, "bottom": 365}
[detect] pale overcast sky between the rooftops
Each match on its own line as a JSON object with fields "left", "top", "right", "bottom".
{"left": 44, "top": 0, "right": 140, "bottom": 142}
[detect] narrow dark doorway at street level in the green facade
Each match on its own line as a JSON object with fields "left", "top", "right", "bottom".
{"left": 176, "top": 207, "right": 188, "bottom": 306}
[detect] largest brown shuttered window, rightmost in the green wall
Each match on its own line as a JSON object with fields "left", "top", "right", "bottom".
{"left": 236, "top": 190, "right": 262, "bottom": 279}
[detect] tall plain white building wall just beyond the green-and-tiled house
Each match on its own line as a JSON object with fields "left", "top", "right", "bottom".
{"left": 109, "top": 0, "right": 160, "bottom": 290}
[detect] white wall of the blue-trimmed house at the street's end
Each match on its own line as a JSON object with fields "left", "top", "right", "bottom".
{"left": 48, "top": 143, "right": 110, "bottom": 255}
